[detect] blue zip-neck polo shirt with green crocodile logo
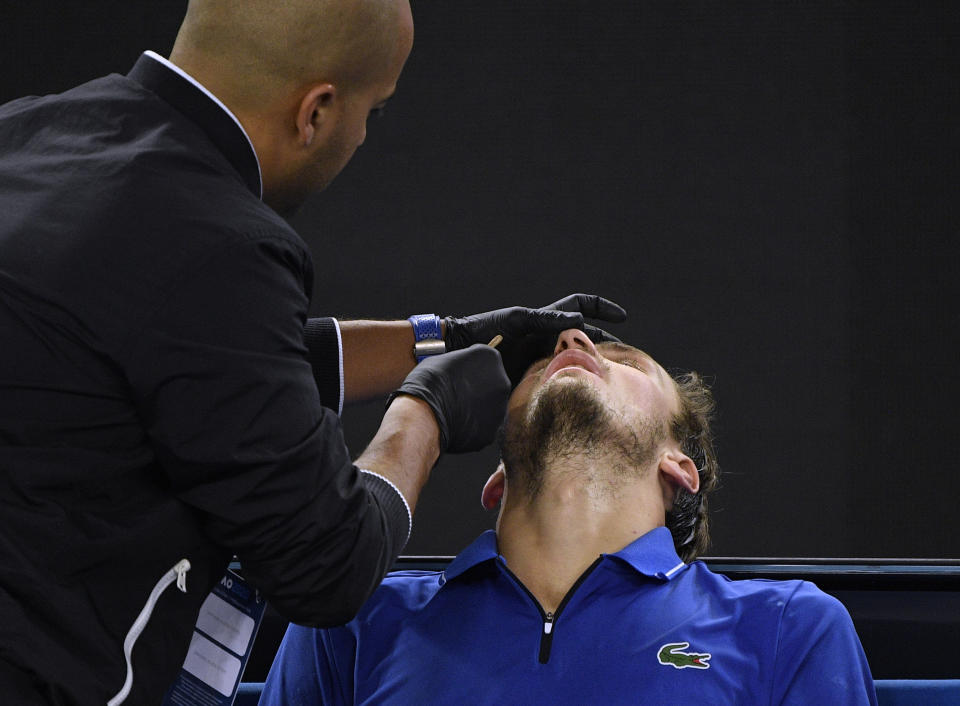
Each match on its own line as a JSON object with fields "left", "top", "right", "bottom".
{"left": 260, "top": 527, "right": 876, "bottom": 706}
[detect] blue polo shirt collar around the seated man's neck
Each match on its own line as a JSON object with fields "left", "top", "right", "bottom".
{"left": 443, "top": 527, "right": 688, "bottom": 583}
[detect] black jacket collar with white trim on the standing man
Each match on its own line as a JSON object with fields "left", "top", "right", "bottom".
{"left": 127, "top": 51, "right": 263, "bottom": 199}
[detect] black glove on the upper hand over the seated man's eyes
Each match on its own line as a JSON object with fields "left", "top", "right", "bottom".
{"left": 443, "top": 294, "right": 627, "bottom": 386}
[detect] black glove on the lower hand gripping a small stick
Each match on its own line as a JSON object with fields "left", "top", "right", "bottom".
{"left": 387, "top": 345, "right": 510, "bottom": 453}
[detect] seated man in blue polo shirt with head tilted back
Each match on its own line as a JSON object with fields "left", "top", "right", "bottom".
{"left": 260, "top": 330, "right": 876, "bottom": 706}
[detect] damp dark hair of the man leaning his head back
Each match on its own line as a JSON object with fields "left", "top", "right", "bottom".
{"left": 666, "top": 372, "right": 720, "bottom": 562}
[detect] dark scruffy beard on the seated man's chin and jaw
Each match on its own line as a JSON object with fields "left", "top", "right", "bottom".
{"left": 500, "top": 380, "right": 667, "bottom": 501}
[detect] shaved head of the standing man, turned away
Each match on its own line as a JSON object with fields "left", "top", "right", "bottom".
{"left": 170, "top": 0, "right": 413, "bottom": 209}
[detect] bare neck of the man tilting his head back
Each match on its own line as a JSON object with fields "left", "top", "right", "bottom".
{"left": 497, "top": 459, "right": 664, "bottom": 612}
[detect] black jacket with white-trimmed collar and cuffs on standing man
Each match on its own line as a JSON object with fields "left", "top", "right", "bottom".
{"left": 0, "top": 56, "right": 409, "bottom": 704}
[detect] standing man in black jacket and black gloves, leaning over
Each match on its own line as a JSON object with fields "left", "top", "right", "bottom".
{"left": 0, "top": 0, "right": 623, "bottom": 704}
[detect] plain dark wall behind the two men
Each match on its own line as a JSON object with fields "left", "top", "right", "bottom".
{"left": 0, "top": 0, "right": 960, "bottom": 557}
